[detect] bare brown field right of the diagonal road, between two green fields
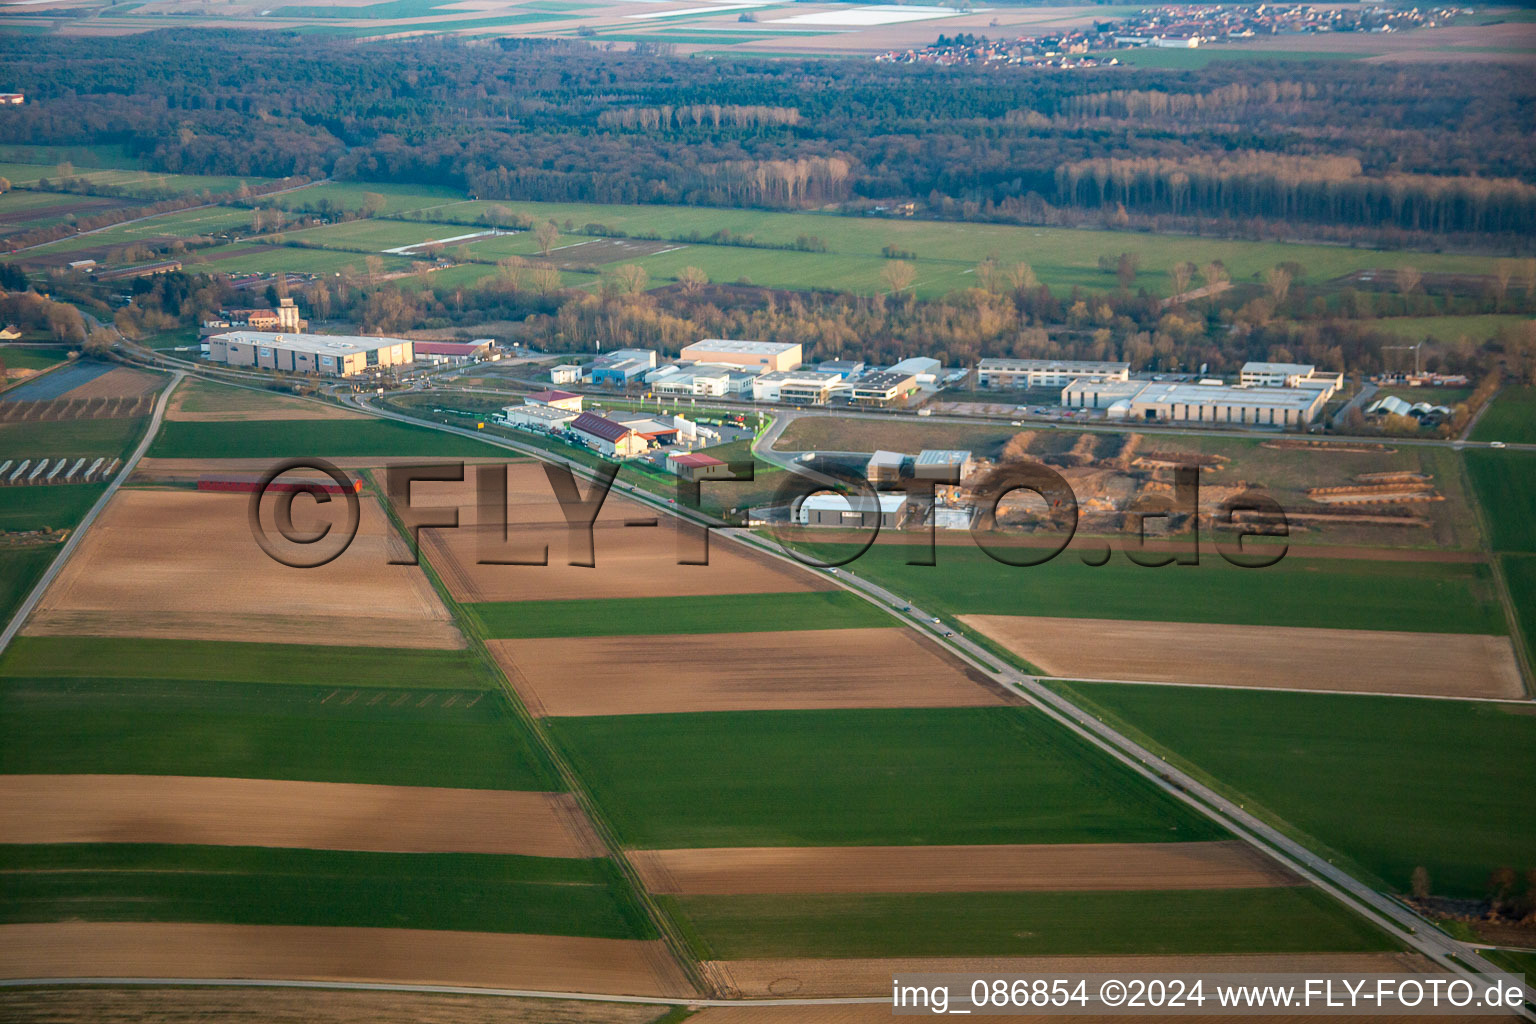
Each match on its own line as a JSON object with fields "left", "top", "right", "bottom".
{"left": 960, "top": 616, "right": 1525, "bottom": 697}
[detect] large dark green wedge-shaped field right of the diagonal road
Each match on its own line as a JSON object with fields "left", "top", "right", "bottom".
{"left": 1055, "top": 683, "right": 1536, "bottom": 898}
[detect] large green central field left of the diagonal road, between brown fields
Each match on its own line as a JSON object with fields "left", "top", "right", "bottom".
{"left": 545, "top": 708, "right": 1224, "bottom": 847}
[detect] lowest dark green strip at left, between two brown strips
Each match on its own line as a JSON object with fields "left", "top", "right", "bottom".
{"left": 0, "top": 843, "right": 651, "bottom": 938}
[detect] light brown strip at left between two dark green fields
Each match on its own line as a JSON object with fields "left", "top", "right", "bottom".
{"left": 0, "top": 775, "right": 602, "bottom": 857}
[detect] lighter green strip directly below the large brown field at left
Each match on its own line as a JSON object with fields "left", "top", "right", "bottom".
{"left": 0, "top": 637, "right": 499, "bottom": 691}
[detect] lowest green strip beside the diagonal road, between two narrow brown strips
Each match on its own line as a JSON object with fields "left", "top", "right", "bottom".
{"left": 660, "top": 887, "right": 1396, "bottom": 961}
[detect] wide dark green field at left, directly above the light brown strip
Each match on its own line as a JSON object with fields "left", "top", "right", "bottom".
{"left": 0, "top": 679, "right": 559, "bottom": 791}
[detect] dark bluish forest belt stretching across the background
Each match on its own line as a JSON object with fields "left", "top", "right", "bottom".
{"left": 0, "top": 31, "right": 1536, "bottom": 253}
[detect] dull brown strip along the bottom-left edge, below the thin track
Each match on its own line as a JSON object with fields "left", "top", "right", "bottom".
{"left": 0, "top": 987, "right": 672, "bottom": 1024}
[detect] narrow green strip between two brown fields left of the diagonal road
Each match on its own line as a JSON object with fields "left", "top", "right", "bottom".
{"left": 464, "top": 590, "right": 892, "bottom": 640}
